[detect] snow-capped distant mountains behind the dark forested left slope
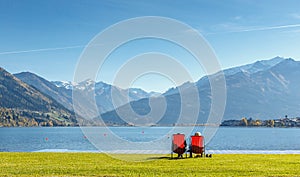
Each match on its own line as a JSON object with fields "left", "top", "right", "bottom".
{"left": 14, "top": 72, "right": 156, "bottom": 113}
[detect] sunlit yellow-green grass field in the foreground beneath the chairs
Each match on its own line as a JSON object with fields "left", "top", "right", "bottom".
{"left": 0, "top": 152, "right": 300, "bottom": 176}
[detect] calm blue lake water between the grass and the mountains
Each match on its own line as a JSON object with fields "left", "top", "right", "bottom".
{"left": 0, "top": 127, "right": 300, "bottom": 152}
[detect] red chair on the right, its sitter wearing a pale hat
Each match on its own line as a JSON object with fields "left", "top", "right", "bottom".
{"left": 190, "top": 136, "right": 205, "bottom": 157}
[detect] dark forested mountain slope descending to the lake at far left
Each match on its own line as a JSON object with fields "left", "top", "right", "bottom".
{"left": 0, "top": 68, "right": 76, "bottom": 125}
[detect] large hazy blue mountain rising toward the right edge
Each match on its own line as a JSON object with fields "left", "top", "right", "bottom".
{"left": 102, "top": 57, "right": 300, "bottom": 125}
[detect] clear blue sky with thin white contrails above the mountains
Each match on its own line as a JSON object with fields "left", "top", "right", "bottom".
{"left": 0, "top": 0, "right": 300, "bottom": 91}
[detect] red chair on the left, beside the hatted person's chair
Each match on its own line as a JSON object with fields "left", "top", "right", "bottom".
{"left": 171, "top": 133, "right": 187, "bottom": 158}
